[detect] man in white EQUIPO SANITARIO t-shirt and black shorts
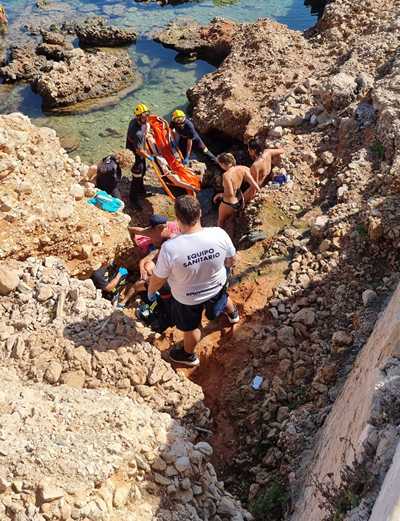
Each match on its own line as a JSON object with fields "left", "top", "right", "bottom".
{"left": 148, "top": 195, "right": 239, "bottom": 366}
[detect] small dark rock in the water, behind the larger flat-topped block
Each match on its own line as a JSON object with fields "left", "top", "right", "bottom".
{"left": 76, "top": 16, "right": 137, "bottom": 47}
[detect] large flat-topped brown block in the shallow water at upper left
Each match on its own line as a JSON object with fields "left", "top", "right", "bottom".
{"left": 33, "top": 49, "right": 135, "bottom": 109}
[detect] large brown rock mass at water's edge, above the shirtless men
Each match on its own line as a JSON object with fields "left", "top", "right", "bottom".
{"left": 188, "top": 20, "right": 316, "bottom": 139}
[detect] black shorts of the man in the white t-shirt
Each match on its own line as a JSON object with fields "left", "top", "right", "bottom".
{"left": 171, "top": 285, "right": 228, "bottom": 331}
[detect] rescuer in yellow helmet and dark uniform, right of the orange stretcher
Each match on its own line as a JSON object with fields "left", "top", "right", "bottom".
{"left": 169, "top": 109, "right": 218, "bottom": 165}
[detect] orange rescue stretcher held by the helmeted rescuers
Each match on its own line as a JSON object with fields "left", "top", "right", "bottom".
{"left": 146, "top": 114, "right": 201, "bottom": 200}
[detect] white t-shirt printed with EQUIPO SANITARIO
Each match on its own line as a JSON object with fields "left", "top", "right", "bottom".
{"left": 154, "top": 228, "right": 236, "bottom": 305}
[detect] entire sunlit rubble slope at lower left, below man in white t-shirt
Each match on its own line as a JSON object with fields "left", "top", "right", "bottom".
{"left": 0, "top": 257, "right": 251, "bottom": 521}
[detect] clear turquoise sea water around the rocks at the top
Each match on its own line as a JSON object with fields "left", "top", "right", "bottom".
{"left": 0, "top": 0, "right": 321, "bottom": 162}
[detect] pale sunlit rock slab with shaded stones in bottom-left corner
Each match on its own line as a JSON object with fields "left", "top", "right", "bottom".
{"left": 0, "top": 368, "right": 252, "bottom": 521}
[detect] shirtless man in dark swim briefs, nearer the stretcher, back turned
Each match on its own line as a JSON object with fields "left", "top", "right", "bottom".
{"left": 214, "top": 154, "right": 260, "bottom": 228}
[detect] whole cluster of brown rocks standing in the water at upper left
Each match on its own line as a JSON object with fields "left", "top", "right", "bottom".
{"left": 0, "top": 28, "right": 141, "bottom": 111}
